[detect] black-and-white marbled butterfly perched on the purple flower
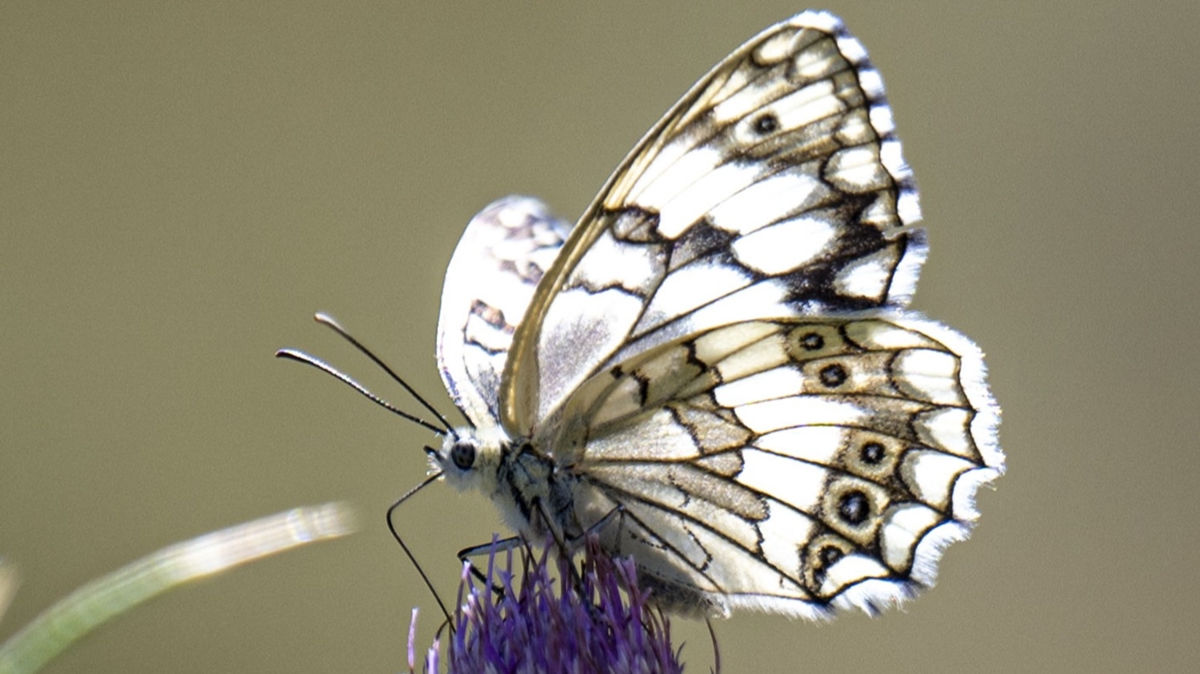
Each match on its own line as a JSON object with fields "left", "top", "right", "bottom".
{"left": 428, "top": 12, "right": 1004, "bottom": 618}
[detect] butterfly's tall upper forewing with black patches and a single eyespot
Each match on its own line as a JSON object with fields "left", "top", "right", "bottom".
{"left": 500, "top": 12, "right": 925, "bottom": 434}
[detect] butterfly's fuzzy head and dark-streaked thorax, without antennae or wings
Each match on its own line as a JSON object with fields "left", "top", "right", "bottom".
{"left": 430, "top": 427, "right": 582, "bottom": 542}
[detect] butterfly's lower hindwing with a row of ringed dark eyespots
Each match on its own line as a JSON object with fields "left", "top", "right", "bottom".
{"left": 554, "top": 311, "right": 1002, "bottom": 618}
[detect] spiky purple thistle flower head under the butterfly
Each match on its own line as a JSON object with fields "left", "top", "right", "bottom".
{"left": 408, "top": 538, "right": 683, "bottom": 674}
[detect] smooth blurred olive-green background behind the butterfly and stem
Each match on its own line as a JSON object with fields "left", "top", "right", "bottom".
{"left": 0, "top": 1, "right": 1200, "bottom": 673}
